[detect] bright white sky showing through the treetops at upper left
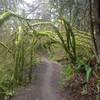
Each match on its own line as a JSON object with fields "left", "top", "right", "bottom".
{"left": 17, "top": 0, "right": 55, "bottom": 21}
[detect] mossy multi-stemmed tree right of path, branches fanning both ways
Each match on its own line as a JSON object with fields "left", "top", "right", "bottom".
{"left": 33, "top": 19, "right": 93, "bottom": 64}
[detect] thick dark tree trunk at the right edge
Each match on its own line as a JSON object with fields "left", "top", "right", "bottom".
{"left": 94, "top": 0, "right": 100, "bottom": 63}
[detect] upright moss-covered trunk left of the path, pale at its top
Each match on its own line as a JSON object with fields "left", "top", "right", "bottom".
{"left": 13, "top": 27, "right": 24, "bottom": 86}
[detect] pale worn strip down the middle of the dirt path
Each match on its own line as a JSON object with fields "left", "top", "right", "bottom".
{"left": 41, "top": 59, "right": 59, "bottom": 100}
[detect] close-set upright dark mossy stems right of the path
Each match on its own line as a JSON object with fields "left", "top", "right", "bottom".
{"left": 63, "top": 19, "right": 76, "bottom": 64}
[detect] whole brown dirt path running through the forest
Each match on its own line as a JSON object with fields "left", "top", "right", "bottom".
{"left": 11, "top": 58, "right": 70, "bottom": 100}
